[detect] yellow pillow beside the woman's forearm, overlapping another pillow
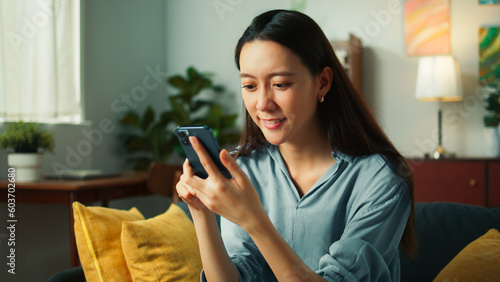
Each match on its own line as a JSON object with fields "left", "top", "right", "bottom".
{"left": 121, "top": 204, "right": 202, "bottom": 281}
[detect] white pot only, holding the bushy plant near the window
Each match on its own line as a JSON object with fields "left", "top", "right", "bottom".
{"left": 7, "top": 153, "right": 43, "bottom": 182}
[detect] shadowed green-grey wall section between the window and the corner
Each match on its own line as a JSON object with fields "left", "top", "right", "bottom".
{"left": 83, "top": 0, "right": 166, "bottom": 170}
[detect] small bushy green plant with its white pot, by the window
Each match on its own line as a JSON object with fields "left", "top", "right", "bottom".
{"left": 0, "top": 121, "right": 54, "bottom": 182}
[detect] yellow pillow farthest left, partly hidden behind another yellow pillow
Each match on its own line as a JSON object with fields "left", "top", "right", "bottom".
{"left": 73, "top": 202, "right": 144, "bottom": 281}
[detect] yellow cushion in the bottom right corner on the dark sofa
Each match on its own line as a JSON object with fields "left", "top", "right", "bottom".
{"left": 434, "top": 229, "right": 500, "bottom": 281}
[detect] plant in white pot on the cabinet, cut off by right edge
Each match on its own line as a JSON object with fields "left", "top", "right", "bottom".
{"left": 483, "top": 82, "right": 500, "bottom": 157}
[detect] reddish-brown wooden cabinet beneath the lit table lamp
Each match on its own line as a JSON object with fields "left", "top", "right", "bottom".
{"left": 410, "top": 159, "right": 500, "bottom": 207}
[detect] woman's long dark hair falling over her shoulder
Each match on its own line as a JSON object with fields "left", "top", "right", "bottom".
{"left": 235, "top": 10, "right": 417, "bottom": 256}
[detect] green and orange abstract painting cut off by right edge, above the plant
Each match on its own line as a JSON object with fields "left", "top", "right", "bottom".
{"left": 479, "top": 26, "right": 500, "bottom": 83}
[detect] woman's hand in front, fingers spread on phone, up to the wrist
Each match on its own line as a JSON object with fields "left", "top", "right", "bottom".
{"left": 177, "top": 137, "right": 267, "bottom": 229}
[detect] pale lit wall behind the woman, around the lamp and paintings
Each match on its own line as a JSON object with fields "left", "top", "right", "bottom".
{"left": 166, "top": 0, "right": 500, "bottom": 157}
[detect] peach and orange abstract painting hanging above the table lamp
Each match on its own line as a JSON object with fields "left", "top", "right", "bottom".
{"left": 404, "top": 0, "right": 451, "bottom": 56}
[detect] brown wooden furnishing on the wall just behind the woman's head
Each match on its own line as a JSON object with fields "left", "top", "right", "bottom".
{"left": 331, "top": 34, "right": 363, "bottom": 95}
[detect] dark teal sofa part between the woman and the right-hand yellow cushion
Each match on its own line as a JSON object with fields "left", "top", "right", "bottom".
{"left": 400, "top": 203, "right": 500, "bottom": 282}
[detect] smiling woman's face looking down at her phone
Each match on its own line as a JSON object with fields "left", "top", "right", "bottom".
{"left": 240, "top": 40, "right": 329, "bottom": 145}
